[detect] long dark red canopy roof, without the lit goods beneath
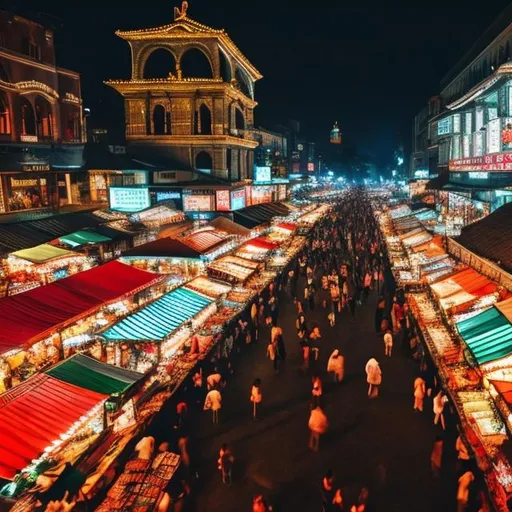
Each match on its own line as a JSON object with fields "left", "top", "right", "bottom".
{"left": 0, "top": 261, "right": 160, "bottom": 353}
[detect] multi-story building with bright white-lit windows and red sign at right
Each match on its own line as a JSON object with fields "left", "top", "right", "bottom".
{"left": 422, "top": 5, "right": 512, "bottom": 224}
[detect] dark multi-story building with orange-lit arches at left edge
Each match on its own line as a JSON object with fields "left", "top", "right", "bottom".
{"left": 0, "top": 11, "right": 86, "bottom": 213}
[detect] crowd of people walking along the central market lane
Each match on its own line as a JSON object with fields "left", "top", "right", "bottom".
{"left": 99, "top": 189, "right": 488, "bottom": 512}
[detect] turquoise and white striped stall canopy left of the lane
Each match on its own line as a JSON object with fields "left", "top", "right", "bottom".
{"left": 101, "top": 288, "right": 213, "bottom": 341}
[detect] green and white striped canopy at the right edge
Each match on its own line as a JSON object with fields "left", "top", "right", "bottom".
{"left": 457, "top": 307, "right": 512, "bottom": 364}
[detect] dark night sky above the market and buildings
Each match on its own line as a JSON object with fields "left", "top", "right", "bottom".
{"left": 11, "top": 0, "right": 508, "bottom": 164}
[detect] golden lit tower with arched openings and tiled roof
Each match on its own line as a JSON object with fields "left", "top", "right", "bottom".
{"left": 106, "top": 2, "right": 262, "bottom": 181}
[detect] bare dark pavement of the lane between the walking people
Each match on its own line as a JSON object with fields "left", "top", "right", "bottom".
{"left": 184, "top": 274, "right": 455, "bottom": 511}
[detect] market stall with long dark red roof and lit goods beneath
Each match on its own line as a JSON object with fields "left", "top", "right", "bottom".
{"left": 0, "top": 261, "right": 162, "bottom": 389}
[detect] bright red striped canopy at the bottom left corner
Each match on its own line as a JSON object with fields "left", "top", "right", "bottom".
{"left": 0, "top": 374, "right": 108, "bottom": 479}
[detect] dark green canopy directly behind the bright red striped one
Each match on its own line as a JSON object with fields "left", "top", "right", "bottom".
{"left": 45, "top": 354, "right": 144, "bottom": 395}
